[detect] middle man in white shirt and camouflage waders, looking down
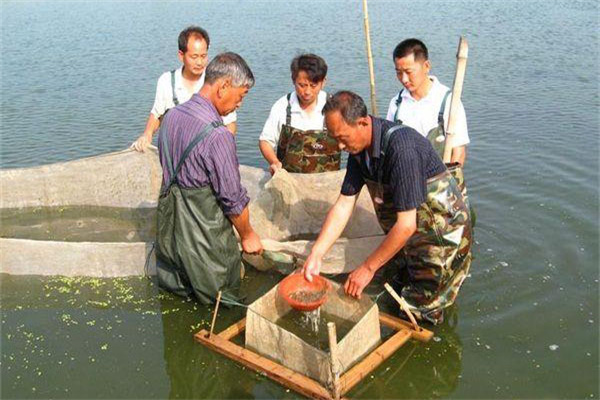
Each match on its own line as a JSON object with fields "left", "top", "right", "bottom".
{"left": 259, "top": 54, "right": 341, "bottom": 174}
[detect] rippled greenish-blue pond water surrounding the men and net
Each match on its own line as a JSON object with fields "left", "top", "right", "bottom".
{"left": 0, "top": 0, "right": 600, "bottom": 398}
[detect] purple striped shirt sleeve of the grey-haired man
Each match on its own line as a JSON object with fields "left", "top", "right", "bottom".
{"left": 205, "top": 127, "right": 250, "bottom": 215}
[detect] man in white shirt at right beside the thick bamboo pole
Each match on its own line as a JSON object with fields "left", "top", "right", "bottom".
{"left": 386, "top": 39, "right": 469, "bottom": 165}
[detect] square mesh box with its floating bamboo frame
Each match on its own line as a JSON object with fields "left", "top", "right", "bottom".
{"left": 194, "top": 277, "right": 433, "bottom": 399}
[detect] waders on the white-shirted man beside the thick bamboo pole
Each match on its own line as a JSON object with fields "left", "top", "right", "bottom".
{"left": 394, "top": 89, "right": 476, "bottom": 226}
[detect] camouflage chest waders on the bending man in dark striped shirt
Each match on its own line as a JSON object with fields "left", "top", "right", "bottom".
{"left": 361, "top": 125, "right": 472, "bottom": 324}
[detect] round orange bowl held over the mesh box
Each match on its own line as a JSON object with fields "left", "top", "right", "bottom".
{"left": 278, "top": 274, "right": 331, "bottom": 311}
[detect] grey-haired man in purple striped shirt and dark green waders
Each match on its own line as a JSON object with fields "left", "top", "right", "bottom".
{"left": 156, "top": 53, "right": 262, "bottom": 304}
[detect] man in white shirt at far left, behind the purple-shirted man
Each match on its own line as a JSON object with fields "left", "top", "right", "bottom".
{"left": 131, "top": 26, "right": 237, "bottom": 152}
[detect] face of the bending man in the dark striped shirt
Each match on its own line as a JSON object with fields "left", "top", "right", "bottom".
{"left": 325, "top": 111, "right": 369, "bottom": 154}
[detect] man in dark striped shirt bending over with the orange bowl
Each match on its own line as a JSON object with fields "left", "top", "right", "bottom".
{"left": 303, "top": 91, "right": 471, "bottom": 324}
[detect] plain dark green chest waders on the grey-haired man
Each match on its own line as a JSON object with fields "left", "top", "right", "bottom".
{"left": 156, "top": 122, "right": 242, "bottom": 304}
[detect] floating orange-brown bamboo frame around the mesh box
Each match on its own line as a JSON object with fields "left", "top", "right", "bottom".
{"left": 194, "top": 312, "right": 433, "bottom": 399}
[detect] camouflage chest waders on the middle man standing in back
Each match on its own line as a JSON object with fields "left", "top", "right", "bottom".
{"left": 277, "top": 93, "right": 342, "bottom": 174}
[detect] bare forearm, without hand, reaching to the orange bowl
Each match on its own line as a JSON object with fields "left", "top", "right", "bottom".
{"left": 311, "top": 194, "right": 358, "bottom": 257}
